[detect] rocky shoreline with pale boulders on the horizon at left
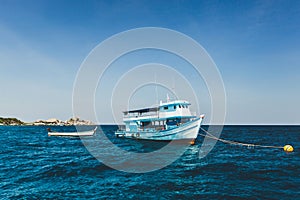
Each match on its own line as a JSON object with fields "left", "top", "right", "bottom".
{"left": 0, "top": 117, "right": 95, "bottom": 126}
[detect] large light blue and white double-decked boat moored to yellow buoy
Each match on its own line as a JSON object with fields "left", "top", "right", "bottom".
{"left": 115, "top": 99, "right": 204, "bottom": 141}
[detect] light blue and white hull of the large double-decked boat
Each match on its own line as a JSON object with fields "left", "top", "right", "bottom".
{"left": 115, "top": 118, "right": 203, "bottom": 141}
